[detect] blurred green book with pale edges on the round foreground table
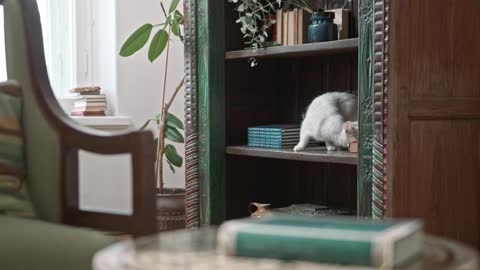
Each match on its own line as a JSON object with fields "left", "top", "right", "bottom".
{"left": 218, "top": 215, "right": 423, "bottom": 268}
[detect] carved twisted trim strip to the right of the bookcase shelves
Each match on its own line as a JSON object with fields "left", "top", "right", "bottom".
{"left": 372, "top": 0, "right": 390, "bottom": 219}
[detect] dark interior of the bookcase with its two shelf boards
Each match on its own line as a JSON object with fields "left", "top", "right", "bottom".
{"left": 219, "top": 2, "right": 358, "bottom": 219}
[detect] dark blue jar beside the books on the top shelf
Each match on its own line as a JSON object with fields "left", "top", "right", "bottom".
{"left": 308, "top": 12, "right": 338, "bottom": 43}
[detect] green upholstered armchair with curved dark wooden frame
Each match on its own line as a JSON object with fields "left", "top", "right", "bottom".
{"left": 0, "top": 0, "right": 156, "bottom": 269}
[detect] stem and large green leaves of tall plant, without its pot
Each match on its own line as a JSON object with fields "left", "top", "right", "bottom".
{"left": 120, "top": 0, "right": 185, "bottom": 193}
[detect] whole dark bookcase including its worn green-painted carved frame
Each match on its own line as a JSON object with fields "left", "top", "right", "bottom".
{"left": 186, "top": 0, "right": 372, "bottom": 224}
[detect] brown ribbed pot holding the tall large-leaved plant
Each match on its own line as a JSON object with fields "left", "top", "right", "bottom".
{"left": 157, "top": 189, "right": 185, "bottom": 231}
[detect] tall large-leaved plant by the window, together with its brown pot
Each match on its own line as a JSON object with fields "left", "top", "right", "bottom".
{"left": 120, "top": 0, "right": 185, "bottom": 230}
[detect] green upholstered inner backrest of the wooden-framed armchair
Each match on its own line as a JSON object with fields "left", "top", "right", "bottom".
{"left": 4, "top": 0, "right": 60, "bottom": 222}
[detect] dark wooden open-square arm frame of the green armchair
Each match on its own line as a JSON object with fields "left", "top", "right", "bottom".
{"left": 60, "top": 126, "right": 157, "bottom": 236}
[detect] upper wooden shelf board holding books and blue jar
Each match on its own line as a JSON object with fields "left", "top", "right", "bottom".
{"left": 225, "top": 38, "right": 358, "bottom": 59}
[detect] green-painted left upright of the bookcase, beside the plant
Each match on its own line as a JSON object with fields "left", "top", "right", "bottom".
{"left": 196, "top": 0, "right": 225, "bottom": 224}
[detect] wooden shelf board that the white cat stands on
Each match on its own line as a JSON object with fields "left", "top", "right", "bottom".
{"left": 226, "top": 146, "right": 357, "bottom": 165}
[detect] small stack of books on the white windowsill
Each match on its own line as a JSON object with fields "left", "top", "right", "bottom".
{"left": 70, "top": 86, "right": 107, "bottom": 116}
